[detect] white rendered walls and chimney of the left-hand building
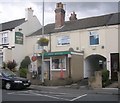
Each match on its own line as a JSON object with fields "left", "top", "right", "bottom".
{"left": 0, "top": 8, "right": 41, "bottom": 67}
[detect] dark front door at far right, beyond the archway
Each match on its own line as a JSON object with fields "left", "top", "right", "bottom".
{"left": 111, "top": 53, "right": 119, "bottom": 80}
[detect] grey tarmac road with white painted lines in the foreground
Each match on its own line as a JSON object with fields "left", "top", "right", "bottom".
{"left": 2, "top": 87, "right": 120, "bottom": 103}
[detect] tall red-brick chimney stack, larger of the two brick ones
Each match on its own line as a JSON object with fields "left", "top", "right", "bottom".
{"left": 55, "top": 2, "right": 65, "bottom": 28}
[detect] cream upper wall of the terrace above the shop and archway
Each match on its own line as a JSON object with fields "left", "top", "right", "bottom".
{"left": 51, "top": 25, "right": 118, "bottom": 77}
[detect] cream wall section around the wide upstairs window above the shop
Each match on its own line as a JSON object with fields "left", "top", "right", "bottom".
{"left": 51, "top": 31, "right": 80, "bottom": 51}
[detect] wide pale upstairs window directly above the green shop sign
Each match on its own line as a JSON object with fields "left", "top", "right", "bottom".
{"left": 57, "top": 36, "right": 70, "bottom": 46}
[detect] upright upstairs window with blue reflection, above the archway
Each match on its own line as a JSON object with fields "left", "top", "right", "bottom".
{"left": 89, "top": 31, "right": 99, "bottom": 45}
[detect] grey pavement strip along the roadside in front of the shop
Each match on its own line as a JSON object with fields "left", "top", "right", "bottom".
{"left": 30, "top": 85, "right": 120, "bottom": 96}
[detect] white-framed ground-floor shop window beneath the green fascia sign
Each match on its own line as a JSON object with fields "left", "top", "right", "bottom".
{"left": 52, "top": 58, "right": 66, "bottom": 70}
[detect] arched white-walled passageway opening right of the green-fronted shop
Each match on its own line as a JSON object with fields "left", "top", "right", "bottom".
{"left": 84, "top": 54, "right": 106, "bottom": 78}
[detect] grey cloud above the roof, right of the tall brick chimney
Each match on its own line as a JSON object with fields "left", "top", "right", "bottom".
{"left": 63, "top": 2, "right": 118, "bottom": 19}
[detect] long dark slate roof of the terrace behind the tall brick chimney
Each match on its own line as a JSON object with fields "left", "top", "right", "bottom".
{"left": 29, "top": 13, "right": 120, "bottom": 36}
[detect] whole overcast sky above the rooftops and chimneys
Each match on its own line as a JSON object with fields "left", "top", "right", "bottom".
{"left": 0, "top": 0, "right": 118, "bottom": 25}
